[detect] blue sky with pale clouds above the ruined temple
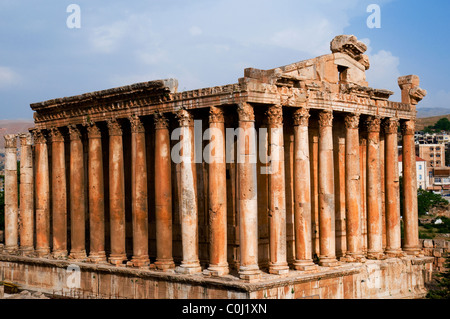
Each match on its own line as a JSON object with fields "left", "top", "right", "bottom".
{"left": 0, "top": 0, "right": 450, "bottom": 120}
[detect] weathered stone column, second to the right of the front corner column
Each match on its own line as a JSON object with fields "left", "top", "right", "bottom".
{"left": 293, "top": 108, "right": 317, "bottom": 270}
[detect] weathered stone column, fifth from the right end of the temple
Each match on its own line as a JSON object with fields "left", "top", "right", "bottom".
{"left": 318, "top": 111, "right": 339, "bottom": 267}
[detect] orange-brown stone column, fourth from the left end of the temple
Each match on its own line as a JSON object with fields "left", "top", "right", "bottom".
{"left": 50, "top": 128, "right": 67, "bottom": 259}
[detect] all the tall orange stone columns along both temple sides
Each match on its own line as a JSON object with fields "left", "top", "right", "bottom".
{"left": 1, "top": 103, "right": 419, "bottom": 281}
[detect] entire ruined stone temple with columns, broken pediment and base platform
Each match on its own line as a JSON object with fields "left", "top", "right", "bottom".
{"left": 0, "top": 35, "right": 432, "bottom": 299}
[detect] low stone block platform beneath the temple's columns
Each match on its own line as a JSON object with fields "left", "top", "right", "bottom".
{"left": 0, "top": 254, "right": 433, "bottom": 299}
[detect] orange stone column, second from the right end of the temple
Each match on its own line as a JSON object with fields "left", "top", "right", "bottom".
{"left": 384, "top": 118, "right": 403, "bottom": 257}
